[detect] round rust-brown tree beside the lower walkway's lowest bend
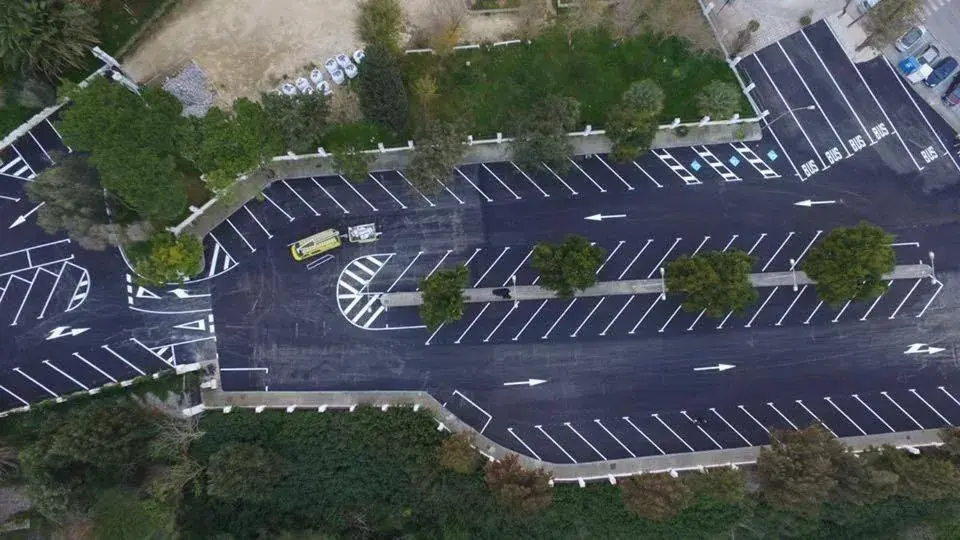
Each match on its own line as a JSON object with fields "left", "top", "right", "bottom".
{"left": 483, "top": 454, "right": 553, "bottom": 514}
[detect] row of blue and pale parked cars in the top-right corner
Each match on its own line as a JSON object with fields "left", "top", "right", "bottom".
{"left": 894, "top": 25, "right": 960, "bottom": 107}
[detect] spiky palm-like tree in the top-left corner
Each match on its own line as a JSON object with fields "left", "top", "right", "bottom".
{"left": 0, "top": 0, "right": 99, "bottom": 79}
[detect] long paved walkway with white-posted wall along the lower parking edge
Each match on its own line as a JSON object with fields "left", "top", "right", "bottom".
{"left": 203, "top": 390, "right": 941, "bottom": 484}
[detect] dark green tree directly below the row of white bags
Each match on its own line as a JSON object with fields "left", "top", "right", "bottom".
{"left": 260, "top": 92, "right": 330, "bottom": 154}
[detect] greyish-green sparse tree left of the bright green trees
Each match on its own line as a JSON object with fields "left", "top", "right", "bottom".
{"left": 26, "top": 153, "right": 152, "bottom": 251}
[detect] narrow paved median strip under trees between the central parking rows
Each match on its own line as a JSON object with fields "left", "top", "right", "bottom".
{"left": 380, "top": 264, "right": 932, "bottom": 308}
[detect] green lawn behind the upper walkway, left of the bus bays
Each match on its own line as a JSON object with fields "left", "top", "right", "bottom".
{"left": 402, "top": 28, "right": 752, "bottom": 138}
